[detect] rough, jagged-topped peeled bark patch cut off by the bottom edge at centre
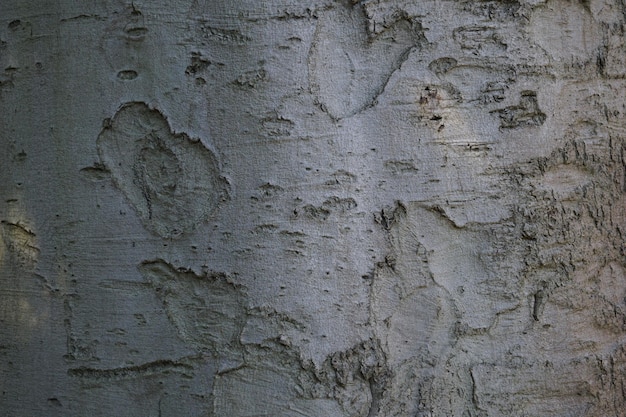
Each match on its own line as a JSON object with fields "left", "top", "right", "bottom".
{"left": 213, "top": 338, "right": 382, "bottom": 417}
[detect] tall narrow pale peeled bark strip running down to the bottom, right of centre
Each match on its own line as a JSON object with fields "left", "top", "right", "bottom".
{"left": 368, "top": 202, "right": 464, "bottom": 417}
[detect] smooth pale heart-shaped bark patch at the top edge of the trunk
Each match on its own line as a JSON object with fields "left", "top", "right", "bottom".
{"left": 309, "top": 5, "right": 425, "bottom": 119}
